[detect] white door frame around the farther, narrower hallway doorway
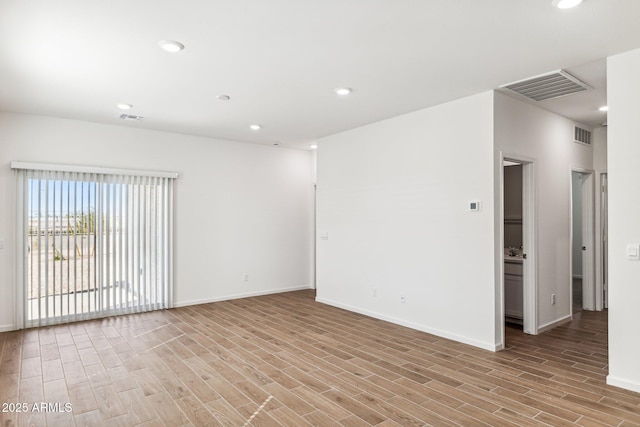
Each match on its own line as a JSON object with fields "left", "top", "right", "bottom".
{"left": 569, "top": 167, "right": 602, "bottom": 317}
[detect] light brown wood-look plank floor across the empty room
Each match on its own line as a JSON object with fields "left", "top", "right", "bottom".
{"left": 0, "top": 291, "right": 640, "bottom": 427}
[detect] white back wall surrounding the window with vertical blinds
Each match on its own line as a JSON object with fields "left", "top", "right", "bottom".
{"left": 0, "top": 114, "right": 313, "bottom": 330}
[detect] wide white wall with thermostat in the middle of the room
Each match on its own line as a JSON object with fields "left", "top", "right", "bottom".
{"left": 317, "top": 92, "right": 499, "bottom": 350}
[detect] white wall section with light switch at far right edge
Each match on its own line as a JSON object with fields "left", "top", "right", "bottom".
{"left": 607, "top": 50, "right": 640, "bottom": 392}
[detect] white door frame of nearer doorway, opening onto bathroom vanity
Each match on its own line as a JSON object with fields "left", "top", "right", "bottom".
{"left": 497, "top": 151, "right": 538, "bottom": 343}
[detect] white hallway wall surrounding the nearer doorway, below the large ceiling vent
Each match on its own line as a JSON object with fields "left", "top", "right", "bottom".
{"left": 494, "top": 92, "right": 593, "bottom": 329}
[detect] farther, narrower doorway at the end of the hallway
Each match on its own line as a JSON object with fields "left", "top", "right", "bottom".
{"left": 570, "top": 169, "right": 596, "bottom": 315}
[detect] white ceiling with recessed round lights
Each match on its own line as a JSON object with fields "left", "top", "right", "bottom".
{"left": 0, "top": 0, "right": 640, "bottom": 147}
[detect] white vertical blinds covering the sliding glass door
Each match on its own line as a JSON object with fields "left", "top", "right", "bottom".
{"left": 12, "top": 162, "right": 177, "bottom": 327}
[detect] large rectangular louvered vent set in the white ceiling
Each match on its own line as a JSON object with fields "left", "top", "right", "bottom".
{"left": 502, "top": 70, "right": 592, "bottom": 101}
